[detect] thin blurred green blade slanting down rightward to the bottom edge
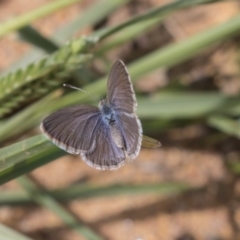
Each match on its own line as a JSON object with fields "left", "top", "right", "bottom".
{"left": 18, "top": 177, "right": 103, "bottom": 240}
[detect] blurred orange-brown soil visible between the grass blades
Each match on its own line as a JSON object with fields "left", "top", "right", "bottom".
{"left": 0, "top": 0, "right": 240, "bottom": 240}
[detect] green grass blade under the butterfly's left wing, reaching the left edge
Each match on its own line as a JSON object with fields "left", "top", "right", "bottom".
{"left": 0, "top": 134, "right": 159, "bottom": 184}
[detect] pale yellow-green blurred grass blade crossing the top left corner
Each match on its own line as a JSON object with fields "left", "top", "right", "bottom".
{"left": 0, "top": 0, "right": 79, "bottom": 37}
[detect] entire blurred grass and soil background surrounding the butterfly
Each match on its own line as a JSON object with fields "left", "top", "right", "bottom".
{"left": 0, "top": 0, "right": 240, "bottom": 240}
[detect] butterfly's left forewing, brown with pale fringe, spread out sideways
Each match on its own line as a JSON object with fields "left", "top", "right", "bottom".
{"left": 41, "top": 105, "right": 101, "bottom": 154}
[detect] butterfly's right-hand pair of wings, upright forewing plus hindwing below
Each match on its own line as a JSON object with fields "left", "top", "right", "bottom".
{"left": 107, "top": 60, "right": 142, "bottom": 158}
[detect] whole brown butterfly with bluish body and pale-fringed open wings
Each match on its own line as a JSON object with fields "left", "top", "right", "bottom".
{"left": 41, "top": 60, "right": 142, "bottom": 170}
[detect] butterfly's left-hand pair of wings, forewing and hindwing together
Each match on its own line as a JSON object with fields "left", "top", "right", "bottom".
{"left": 41, "top": 105, "right": 126, "bottom": 170}
